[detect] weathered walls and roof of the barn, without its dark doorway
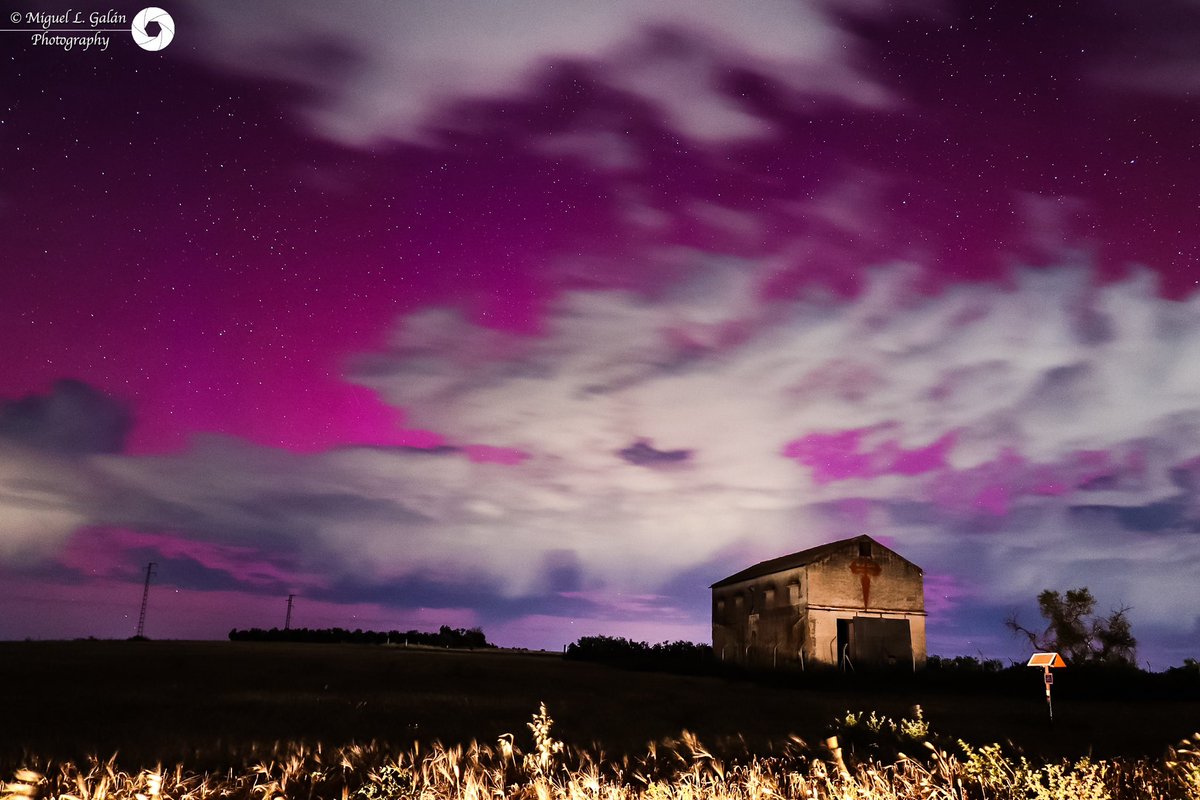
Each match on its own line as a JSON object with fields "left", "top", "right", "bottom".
{"left": 713, "top": 540, "right": 925, "bottom": 668}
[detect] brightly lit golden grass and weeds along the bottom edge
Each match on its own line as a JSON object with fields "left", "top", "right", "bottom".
{"left": 0, "top": 706, "right": 1200, "bottom": 800}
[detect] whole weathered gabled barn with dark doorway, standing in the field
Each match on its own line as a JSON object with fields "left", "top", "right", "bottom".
{"left": 712, "top": 535, "right": 925, "bottom": 670}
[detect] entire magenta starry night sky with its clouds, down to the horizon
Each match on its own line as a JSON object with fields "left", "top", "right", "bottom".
{"left": 0, "top": 0, "right": 1200, "bottom": 669}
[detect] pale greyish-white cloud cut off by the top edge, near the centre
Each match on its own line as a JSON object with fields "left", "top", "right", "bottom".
{"left": 194, "top": 0, "right": 887, "bottom": 145}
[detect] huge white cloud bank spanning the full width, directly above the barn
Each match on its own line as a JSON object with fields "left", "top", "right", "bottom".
{"left": 0, "top": 262, "right": 1200, "bottom": 657}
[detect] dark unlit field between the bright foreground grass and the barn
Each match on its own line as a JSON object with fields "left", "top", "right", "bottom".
{"left": 0, "top": 642, "right": 1200, "bottom": 770}
